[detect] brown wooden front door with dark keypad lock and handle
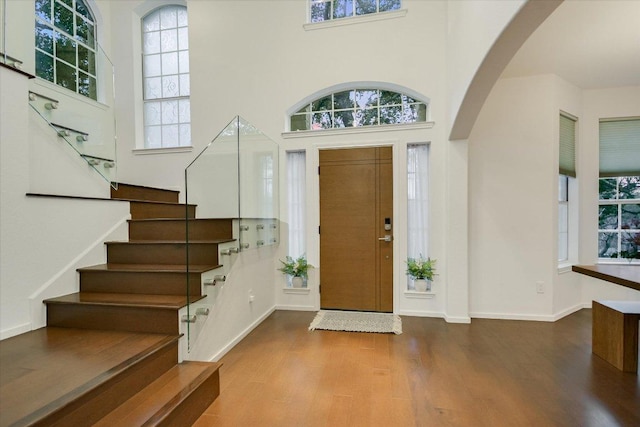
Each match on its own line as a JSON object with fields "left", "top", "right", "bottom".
{"left": 319, "top": 147, "right": 393, "bottom": 312}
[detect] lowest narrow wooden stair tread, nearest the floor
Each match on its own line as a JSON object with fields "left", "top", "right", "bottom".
{"left": 94, "top": 362, "right": 220, "bottom": 427}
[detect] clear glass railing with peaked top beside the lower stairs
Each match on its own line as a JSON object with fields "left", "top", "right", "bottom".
{"left": 185, "top": 116, "right": 280, "bottom": 349}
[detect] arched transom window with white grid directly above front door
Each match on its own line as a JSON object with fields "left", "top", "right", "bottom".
{"left": 291, "top": 89, "right": 427, "bottom": 131}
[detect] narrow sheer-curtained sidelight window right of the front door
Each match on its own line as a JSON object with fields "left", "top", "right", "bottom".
{"left": 407, "top": 144, "right": 429, "bottom": 284}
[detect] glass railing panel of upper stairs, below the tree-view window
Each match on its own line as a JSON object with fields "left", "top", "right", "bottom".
{"left": 29, "top": 47, "right": 118, "bottom": 187}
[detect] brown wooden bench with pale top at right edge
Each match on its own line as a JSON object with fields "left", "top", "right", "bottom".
{"left": 592, "top": 301, "right": 640, "bottom": 372}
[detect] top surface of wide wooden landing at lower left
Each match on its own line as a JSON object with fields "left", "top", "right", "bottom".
{"left": 0, "top": 327, "right": 179, "bottom": 425}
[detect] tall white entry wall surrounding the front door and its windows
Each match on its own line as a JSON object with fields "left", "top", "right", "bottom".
{"left": 112, "top": 1, "right": 466, "bottom": 322}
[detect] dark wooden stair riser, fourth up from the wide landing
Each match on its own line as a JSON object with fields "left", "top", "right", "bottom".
{"left": 129, "top": 219, "right": 233, "bottom": 241}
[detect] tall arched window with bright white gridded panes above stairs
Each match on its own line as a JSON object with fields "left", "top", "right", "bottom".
{"left": 142, "top": 6, "right": 191, "bottom": 148}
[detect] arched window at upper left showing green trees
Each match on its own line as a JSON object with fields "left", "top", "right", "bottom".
{"left": 35, "top": 0, "right": 98, "bottom": 99}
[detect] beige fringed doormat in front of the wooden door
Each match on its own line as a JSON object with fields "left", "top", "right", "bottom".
{"left": 309, "top": 310, "right": 402, "bottom": 334}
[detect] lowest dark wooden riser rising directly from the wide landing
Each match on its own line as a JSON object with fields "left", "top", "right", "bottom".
{"left": 47, "top": 303, "right": 179, "bottom": 335}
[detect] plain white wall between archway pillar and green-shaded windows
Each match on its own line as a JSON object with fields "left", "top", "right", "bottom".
{"left": 469, "top": 75, "right": 558, "bottom": 317}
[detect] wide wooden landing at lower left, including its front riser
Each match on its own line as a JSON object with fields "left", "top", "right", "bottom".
{"left": 0, "top": 327, "right": 179, "bottom": 427}
